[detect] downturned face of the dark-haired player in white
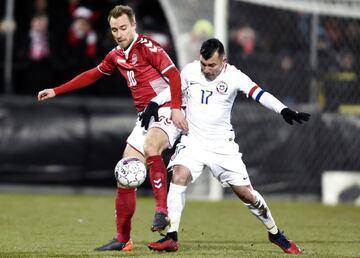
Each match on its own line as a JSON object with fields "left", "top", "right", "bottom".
{"left": 200, "top": 52, "right": 225, "bottom": 81}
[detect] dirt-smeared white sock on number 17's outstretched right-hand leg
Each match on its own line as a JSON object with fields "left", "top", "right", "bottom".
{"left": 245, "top": 190, "right": 278, "bottom": 234}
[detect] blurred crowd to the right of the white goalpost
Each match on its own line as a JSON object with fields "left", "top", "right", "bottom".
{"left": 225, "top": 1, "right": 360, "bottom": 106}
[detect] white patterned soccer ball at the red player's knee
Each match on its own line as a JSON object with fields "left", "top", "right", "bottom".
{"left": 115, "top": 157, "right": 146, "bottom": 188}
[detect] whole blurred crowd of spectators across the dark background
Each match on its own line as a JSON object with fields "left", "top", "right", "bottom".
{"left": 0, "top": 0, "right": 360, "bottom": 108}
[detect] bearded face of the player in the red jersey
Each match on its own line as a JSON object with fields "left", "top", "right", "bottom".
{"left": 109, "top": 14, "right": 136, "bottom": 49}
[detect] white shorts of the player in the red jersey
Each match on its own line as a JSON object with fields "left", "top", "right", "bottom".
{"left": 126, "top": 107, "right": 181, "bottom": 155}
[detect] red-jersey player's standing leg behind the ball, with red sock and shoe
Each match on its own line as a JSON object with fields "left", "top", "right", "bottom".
{"left": 95, "top": 144, "right": 145, "bottom": 251}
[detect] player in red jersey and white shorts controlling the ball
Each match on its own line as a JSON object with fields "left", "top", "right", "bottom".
{"left": 38, "top": 5, "right": 188, "bottom": 251}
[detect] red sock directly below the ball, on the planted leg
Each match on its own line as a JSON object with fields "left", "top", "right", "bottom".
{"left": 115, "top": 188, "right": 136, "bottom": 243}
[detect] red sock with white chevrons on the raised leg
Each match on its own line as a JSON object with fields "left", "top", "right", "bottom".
{"left": 146, "top": 155, "right": 168, "bottom": 215}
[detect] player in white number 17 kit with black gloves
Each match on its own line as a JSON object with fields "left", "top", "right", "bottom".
{"left": 148, "top": 39, "right": 310, "bottom": 254}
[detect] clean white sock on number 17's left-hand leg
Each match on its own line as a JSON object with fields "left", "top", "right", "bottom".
{"left": 167, "top": 183, "right": 187, "bottom": 232}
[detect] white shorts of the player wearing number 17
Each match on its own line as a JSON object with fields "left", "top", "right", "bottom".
{"left": 168, "top": 139, "right": 251, "bottom": 187}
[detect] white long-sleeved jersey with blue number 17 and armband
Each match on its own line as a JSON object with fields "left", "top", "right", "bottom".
{"left": 181, "top": 60, "right": 285, "bottom": 153}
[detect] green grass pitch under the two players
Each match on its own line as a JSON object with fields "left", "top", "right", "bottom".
{"left": 0, "top": 193, "right": 360, "bottom": 258}
